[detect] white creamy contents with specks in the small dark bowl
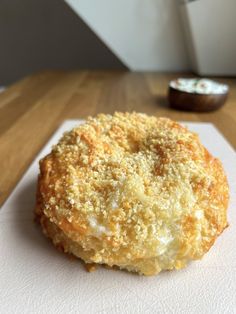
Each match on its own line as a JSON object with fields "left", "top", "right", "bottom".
{"left": 170, "top": 78, "right": 228, "bottom": 95}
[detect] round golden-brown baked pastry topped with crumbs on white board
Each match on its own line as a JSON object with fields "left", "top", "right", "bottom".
{"left": 35, "top": 113, "right": 229, "bottom": 275}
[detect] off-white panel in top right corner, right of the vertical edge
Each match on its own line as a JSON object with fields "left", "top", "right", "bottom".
{"left": 181, "top": 0, "right": 236, "bottom": 76}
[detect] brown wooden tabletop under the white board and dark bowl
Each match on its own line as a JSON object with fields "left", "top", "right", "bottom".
{"left": 0, "top": 71, "right": 236, "bottom": 204}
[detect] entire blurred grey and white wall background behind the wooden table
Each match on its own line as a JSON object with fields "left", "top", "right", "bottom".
{"left": 0, "top": 0, "right": 236, "bottom": 86}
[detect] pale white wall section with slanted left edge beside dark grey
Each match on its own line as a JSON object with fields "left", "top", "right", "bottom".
{"left": 66, "top": 0, "right": 189, "bottom": 71}
